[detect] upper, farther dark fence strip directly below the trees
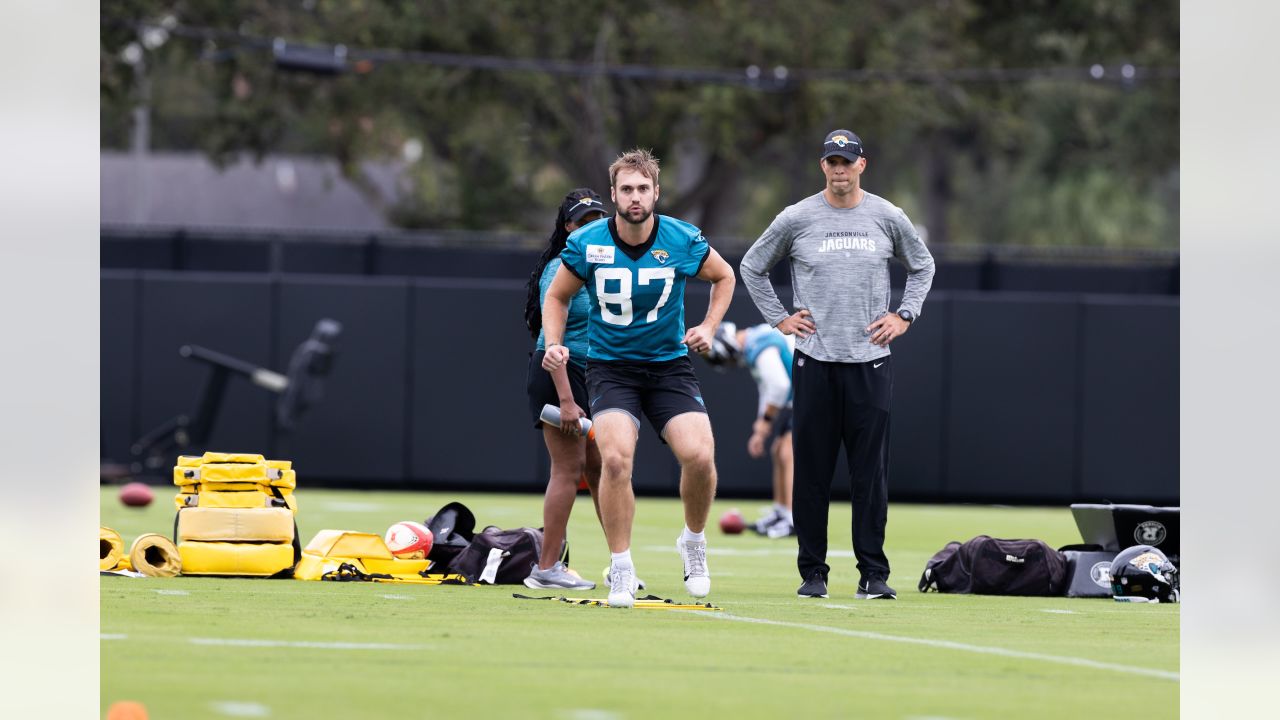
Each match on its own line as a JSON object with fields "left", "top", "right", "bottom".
{"left": 100, "top": 227, "right": 1179, "bottom": 295}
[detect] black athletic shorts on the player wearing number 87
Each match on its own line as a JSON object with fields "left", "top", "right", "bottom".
{"left": 586, "top": 355, "right": 707, "bottom": 442}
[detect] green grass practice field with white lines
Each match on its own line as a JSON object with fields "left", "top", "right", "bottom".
{"left": 100, "top": 484, "right": 1179, "bottom": 720}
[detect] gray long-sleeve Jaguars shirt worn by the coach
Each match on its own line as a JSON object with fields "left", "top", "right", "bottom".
{"left": 740, "top": 191, "right": 933, "bottom": 363}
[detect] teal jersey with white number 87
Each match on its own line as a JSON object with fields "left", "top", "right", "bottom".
{"left": 561, "top": 214, "right": 710, "bottom": 363}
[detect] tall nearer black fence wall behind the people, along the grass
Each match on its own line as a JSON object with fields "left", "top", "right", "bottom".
{"left": 101, "top": 272, "right": 1179, "bottom": 503}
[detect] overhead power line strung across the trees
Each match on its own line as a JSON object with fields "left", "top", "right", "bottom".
{"left": 102, "top": 18, "right": 1179, "bottom": 91}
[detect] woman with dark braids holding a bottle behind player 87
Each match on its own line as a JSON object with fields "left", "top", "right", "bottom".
{"left": 525, "top": 187, "right": 604, "bottom": 589}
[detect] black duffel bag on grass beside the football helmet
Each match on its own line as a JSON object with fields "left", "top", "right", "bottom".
{"left": 919, "top": 536, "right": 1068, "bottom": 596}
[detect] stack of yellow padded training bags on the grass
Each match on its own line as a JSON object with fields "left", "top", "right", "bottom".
{"left": 173, "top": 452, "right": 301, "bottom": 577}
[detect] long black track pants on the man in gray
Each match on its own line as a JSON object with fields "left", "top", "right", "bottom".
{"left": 791, "top": 351, "right": 893, "bottom": 580}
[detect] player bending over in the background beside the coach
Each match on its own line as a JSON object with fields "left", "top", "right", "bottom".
{"left": 703, "top": 323, "right": 795, "bottom": 539}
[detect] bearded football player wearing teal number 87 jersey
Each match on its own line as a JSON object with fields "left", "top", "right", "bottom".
{"left": 543, "top": 150, "right": 735, "bottom": 607}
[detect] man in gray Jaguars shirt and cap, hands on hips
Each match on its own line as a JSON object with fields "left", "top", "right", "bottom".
{"left": 740, "top": 129, "right": 933, "bottom": 600}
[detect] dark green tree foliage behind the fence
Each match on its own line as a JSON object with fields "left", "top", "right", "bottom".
{"left": 101, "top": 0, "right": 1178, "bottom": 247}
